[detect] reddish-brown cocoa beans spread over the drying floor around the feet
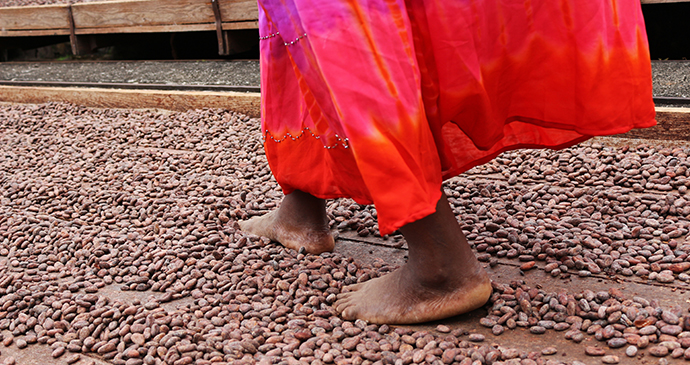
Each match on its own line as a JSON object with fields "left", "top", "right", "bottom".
{"left": 0, "top": 103, "right": 690, "bottom": 365}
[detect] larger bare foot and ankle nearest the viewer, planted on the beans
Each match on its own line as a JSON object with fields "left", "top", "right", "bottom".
{"left": 335, "top": 192, "right": 492, "bottom": 324}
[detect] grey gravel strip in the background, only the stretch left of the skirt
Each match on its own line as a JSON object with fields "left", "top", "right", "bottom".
{"left": 0, "top": 60, "right": 260, "bottom": 86}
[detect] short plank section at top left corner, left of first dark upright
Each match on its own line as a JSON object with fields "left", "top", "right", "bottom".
{"left": 0, "top": 5, "right": 69, "bottom": 30}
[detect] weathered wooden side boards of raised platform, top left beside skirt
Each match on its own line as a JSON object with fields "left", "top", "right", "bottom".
{"left": 0, "top": 0, "right": 258, "bottom": 37}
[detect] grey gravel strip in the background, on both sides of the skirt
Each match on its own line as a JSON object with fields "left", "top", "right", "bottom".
{"left": 0, "top": 60, "right": 690, "bottom": 97}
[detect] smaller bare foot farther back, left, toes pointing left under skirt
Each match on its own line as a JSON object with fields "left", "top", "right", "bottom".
{"left": 240, "top": 191, "right": 335, "bottom": 255}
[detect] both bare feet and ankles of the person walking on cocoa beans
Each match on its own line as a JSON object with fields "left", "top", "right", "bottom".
{"left": 240, "top": 191, "right": 492, "bottom": 324}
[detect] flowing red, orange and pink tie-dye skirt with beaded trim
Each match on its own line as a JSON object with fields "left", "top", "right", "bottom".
{"left": 259, "top": 0, "right": 655, "bottom": 234}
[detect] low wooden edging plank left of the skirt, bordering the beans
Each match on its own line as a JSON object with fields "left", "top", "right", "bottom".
{"left": 0, "top": 86, "right": 261, "bottom": 118}
